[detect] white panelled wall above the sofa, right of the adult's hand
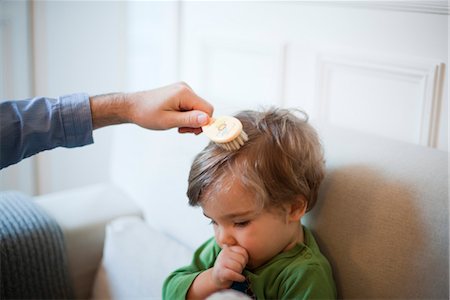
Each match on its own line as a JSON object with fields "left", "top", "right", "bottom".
{"left": 180, "top": 1, "right": 448, "bottom": 150}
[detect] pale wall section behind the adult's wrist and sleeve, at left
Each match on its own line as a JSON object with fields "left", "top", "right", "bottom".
{"left": 33, "top": 1, "right": 126, "bottom": 194}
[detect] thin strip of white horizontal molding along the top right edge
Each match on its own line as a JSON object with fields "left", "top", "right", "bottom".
{"left": 296, "top": 0, "right": 450, "bottom": 15}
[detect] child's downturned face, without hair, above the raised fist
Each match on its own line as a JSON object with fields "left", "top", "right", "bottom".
{"left": 201, "top": 181, "right": 300, "bottom": 269}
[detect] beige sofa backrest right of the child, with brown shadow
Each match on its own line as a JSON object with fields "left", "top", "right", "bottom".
{"left": 305, "top": 127, "right": 449, "bottom": 299}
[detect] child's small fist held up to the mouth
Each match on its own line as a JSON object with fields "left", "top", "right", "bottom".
{"left": 212, "top": 246, "right": 248, "bottom": 289}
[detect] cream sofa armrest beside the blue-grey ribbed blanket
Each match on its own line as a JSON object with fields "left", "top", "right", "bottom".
{"left": 35, "top": 184, "right": 142, "bottom": 299}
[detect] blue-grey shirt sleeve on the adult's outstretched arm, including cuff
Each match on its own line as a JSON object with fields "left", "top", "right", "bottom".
{"left": 0, "top": 93, "right": 93, "bottom": 169}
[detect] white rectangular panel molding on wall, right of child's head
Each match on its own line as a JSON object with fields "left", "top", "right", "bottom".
{"left": 316, "top": 53, "right": 445, "bottom": 147}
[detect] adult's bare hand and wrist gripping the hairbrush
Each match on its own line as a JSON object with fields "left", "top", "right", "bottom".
{"left": 90, "top": 82, "right": 213, "bottom": 134}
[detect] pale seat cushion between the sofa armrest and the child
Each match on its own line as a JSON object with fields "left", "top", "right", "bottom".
{"left": 93, "top": 217, "right": 193, "bottom": 299}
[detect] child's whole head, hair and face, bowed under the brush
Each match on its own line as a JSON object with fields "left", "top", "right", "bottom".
{"left": 187, "top": 109, "right": 324, "bottom": 269}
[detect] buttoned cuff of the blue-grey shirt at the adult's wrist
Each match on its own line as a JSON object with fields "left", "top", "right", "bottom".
{"left": 59, "top": 93, "right": 94, "bottom": 148}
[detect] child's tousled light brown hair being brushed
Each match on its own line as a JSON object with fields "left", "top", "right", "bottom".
{"left": 187, "top": 108, "right": 324, "bottom": 211}
